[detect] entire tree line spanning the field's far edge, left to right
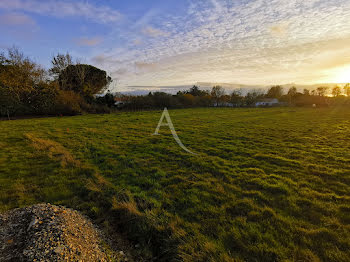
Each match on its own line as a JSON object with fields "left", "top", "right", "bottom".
{"left": 0, "top": 48, "right": 350, "bottom": 118}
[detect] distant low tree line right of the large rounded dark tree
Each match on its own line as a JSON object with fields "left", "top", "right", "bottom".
{"left": 115, "top": 84, "right": 350, "bottom": 110}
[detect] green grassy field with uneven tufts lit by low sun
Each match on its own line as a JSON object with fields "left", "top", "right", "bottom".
{"left": 0, "top": 108, "right": 350, "bottom": 261}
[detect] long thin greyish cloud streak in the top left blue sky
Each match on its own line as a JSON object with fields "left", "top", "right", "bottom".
{"left": 0, "top": 0, "right": 122, "bottom": 24}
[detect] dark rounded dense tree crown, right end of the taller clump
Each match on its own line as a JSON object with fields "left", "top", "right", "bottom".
{"left": 58, "top": 64, "right": 112, "bottom": 98}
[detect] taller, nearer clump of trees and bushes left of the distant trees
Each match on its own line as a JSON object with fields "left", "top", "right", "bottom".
{"left": 0, "top": 47, "right": 112, "bottom": 118}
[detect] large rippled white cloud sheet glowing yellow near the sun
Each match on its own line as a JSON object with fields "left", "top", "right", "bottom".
{"left": 80, "top": 0, "right": 350, "bottom": 86}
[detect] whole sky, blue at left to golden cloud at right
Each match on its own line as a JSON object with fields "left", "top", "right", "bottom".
{"left": 0, "top": 0, "right": 350, "bottom": 90}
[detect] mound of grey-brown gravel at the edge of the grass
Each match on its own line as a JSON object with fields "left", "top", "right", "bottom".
{"left": 0, "top": 204, "right": 132, "bottom": 262}
